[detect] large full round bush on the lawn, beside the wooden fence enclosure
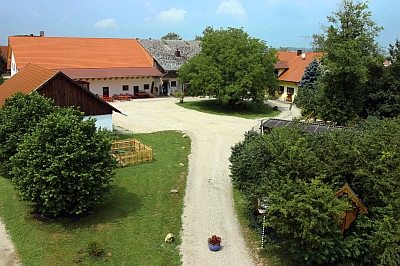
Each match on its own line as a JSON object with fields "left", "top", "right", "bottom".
{"left": 11, "top": 108, "right": 115, "bottom": 218}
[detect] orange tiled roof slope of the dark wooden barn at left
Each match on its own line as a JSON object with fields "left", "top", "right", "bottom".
{"left": 0, "top": 64, "right": 57, "bottom": 106}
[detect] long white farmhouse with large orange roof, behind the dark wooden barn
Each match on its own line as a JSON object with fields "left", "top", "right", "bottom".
{"left": 7, "top": 32, "right": 162, "bottom": 99}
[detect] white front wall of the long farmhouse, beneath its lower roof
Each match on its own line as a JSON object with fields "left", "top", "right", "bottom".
{"left": 88, "top": 78, "right": 160, "bottom": 96}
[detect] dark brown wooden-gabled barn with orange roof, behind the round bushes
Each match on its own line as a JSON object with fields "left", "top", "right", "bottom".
{"left": 0, "top": 64, "right": 121, "bottom": 130}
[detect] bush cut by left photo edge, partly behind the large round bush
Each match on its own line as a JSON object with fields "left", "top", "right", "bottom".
{"left": 0, "top": 92, "right": 57, "bottom": 178}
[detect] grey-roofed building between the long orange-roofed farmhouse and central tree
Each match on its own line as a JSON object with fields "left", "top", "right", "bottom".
{"left": 139, "top": 39, "right": 201, "bottom": 95}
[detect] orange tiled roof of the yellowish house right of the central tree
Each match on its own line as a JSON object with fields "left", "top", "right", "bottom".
{"left": 275, "top": 52, "right": 322, "bottom": 82}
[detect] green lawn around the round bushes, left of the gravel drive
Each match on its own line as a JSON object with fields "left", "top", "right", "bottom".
{"left": 0, "top": 131, "right": 190, "bottom": 265}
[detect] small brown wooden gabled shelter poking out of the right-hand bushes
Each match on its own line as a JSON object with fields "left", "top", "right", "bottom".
{"left": 335, "top": 183, "right": 368, "bottom": 233}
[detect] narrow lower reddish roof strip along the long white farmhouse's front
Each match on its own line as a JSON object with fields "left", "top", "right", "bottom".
{"left": 60, "top": 67, "right": 163, "bottom": 79}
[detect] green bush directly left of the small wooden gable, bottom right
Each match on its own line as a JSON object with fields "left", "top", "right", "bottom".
{"left": 266, "top": 179, "right": 349, "bottom": 265}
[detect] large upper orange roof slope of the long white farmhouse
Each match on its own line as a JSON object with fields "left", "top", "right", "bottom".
{"left": 8, "top": 36, "right": 153, "bottom": 70}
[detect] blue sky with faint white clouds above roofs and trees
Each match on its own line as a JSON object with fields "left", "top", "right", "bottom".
{"left": 0, "top": 0, "right": 400, "bottom": 49}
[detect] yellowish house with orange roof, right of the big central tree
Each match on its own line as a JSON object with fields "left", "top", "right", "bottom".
{"left": 275, "top": 50, "right": 322, "bottom": 102}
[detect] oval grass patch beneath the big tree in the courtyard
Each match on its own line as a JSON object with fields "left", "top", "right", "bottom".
{"left": 177, "top": 100, "right": 280, "bottom": 119}
